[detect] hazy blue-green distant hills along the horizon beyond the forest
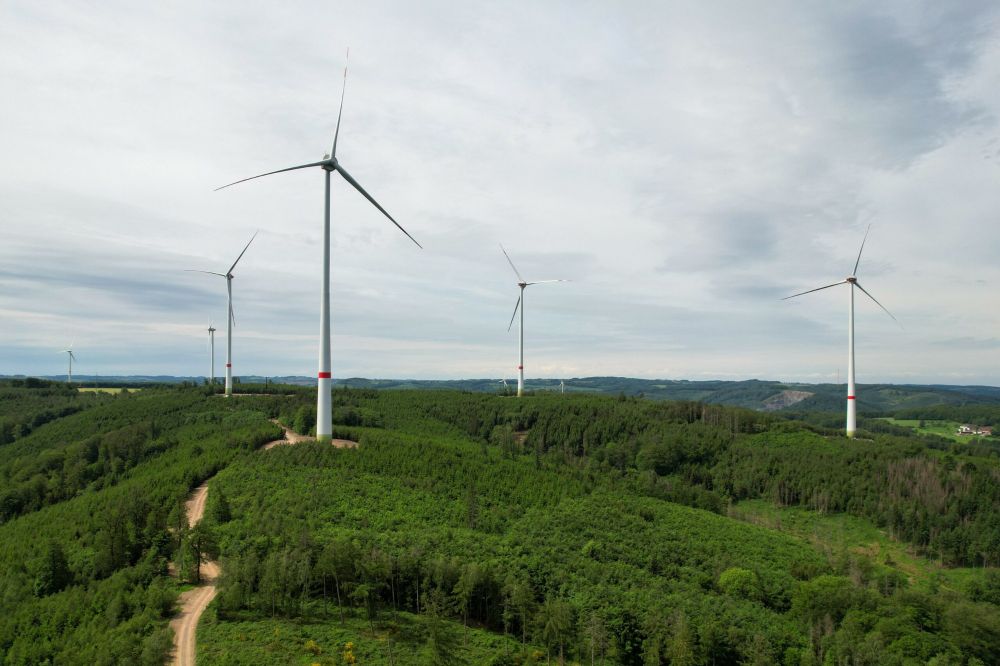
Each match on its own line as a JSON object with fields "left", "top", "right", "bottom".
{"left": 9, "top": 375, "right": 1000, "bottom": 414}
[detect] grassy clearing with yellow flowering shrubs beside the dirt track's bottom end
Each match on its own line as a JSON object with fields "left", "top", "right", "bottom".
{"left": 198, "top": 604, "right": 538, "bottom": 666}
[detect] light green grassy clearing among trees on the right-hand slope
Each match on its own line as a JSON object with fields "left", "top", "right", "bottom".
{"left": 729, "top": 500, "right": 986, "bottom": 592}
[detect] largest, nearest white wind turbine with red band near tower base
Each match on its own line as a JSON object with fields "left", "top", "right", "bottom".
{"left": 216, "top": 54, "right": 422, "bottom": 441}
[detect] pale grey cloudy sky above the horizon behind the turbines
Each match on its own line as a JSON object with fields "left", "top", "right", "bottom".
{"left": 0, "top": 0, "right": 1000, "bottom": 384}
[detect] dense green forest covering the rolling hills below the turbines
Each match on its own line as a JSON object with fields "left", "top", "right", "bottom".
{"left": 0, "top": 380, "right": 1000, "bottom": 666}
